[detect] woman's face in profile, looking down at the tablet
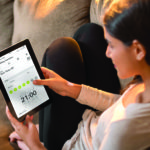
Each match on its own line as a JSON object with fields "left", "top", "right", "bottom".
{"left": 104, "top": 27, "right": 137, "bottom": 79}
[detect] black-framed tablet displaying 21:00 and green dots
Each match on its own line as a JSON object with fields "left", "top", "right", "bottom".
{"left": 0, "top": 39, "right": 52, "bottom": 121}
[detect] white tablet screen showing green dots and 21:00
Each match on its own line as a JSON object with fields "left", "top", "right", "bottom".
{"left": 0, "top": 45, "right": 49, "bottom": 118}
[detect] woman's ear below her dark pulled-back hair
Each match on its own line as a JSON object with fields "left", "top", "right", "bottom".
{"left": 133, "top": 40, "right": 146, "bottom": 61}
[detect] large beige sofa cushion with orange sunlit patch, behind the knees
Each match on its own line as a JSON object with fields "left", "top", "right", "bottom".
{"left": 12, "top": 0, "right": 91, "bottom": 63}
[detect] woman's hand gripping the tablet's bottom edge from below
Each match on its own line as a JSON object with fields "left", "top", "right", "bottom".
{"left": 6, "top": 107, "right": 45, "bottom": 150}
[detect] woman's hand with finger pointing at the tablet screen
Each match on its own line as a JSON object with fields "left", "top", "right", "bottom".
{"left": 33, "top": 67, "right": 81, "bottom": 99}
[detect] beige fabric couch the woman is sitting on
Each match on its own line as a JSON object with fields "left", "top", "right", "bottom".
{"left": 0, "top": 0, "right": 130, "bottom": 150}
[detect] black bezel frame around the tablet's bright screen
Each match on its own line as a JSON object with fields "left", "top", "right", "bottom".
{"left": 0, "top": 39, "right": 52, "bottom": 122}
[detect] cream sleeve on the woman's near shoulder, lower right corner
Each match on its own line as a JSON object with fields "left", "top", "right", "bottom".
{"left": 99, "top": 104, "right": 150, "bottom": 150}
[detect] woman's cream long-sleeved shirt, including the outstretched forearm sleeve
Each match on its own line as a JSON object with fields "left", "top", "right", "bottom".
{"left": 63, "top": 85, "right": 150, "bottom": 150}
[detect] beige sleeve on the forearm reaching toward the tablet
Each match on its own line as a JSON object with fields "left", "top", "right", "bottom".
{"left": 76, "top": 85, "right": 121, "bottom": 111}
